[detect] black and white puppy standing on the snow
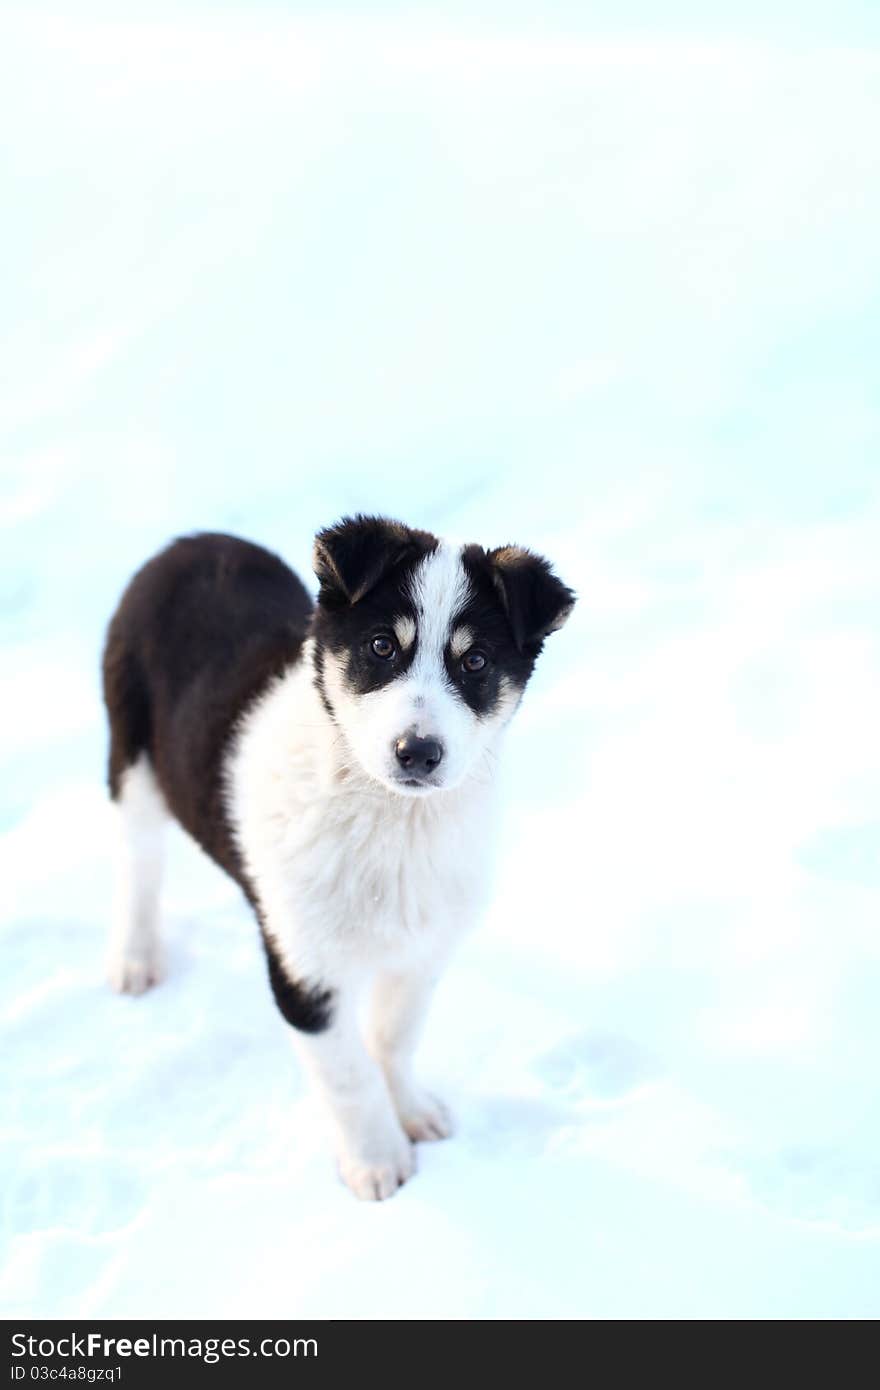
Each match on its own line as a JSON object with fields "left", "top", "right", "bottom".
{"left": 103, "top": 516, "right": 574, "bottom": 1198}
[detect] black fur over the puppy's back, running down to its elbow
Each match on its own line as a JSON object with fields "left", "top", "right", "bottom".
{"left": 103, "top": 534, "right": 331, "bottom": 1033}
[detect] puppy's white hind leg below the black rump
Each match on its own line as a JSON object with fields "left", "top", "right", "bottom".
{"left": 108, "top": 753, "right": 168, "bottom": 994}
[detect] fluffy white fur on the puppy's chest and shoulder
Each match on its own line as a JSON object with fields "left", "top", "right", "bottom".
{"left": 227, "top": 652, "right": 494, "bottom": 983}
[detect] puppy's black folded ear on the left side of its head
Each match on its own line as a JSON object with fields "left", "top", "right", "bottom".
{"left": 313, "top": 516, "right": 437, "bottom": 603}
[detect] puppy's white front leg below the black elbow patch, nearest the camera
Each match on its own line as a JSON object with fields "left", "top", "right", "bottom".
{"left": 293, "top": 991, "right": 416, "bottom": 1201}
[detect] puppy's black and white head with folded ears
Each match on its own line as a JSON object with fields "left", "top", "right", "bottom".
{"left": 314, "top": 516, "right": 574, "bottom": 796}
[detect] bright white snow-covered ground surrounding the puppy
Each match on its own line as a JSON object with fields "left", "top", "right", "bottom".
{"left": 0, "top": 0, "right": 880, "bottom": 1318}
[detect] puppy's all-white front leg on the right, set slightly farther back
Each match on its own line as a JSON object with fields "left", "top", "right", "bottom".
{"left": 367, "top": 970, "right": 453, "bottom": 1140}
